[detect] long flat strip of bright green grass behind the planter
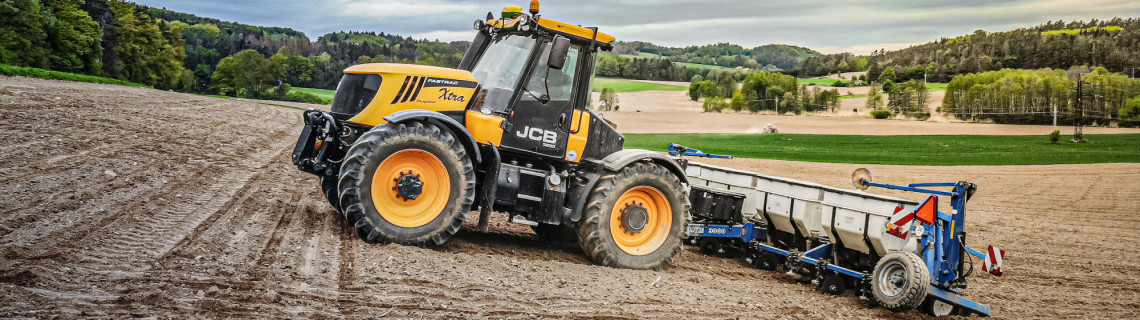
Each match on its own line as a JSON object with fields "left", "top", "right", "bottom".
{"left": 626, "top": 133, "right": 1140, "bottom": 165}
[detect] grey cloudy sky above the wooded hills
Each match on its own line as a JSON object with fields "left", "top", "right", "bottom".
{"left": 135, "top": 0, "right": 1140, "bottom": 55}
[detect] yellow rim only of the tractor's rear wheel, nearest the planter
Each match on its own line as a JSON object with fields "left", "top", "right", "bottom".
{"left": 610, "top": 187, "right": 673, "bottom": 255}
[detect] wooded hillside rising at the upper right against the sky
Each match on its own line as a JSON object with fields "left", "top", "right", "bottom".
{"left": 800, "top": 18, "right": 1140, "bottom": 82}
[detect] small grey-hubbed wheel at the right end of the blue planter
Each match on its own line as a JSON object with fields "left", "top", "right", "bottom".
{"left": 871, "top": 252, "right": 930, "bottom": 312}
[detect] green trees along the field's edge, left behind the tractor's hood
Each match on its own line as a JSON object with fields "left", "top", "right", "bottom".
{"left": 0, "top": 0, "right": 471, "bottom": 100}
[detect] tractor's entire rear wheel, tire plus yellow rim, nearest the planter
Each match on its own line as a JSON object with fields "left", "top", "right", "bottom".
{"left": 578, "top": 163, "right": 691, "bottom": 270}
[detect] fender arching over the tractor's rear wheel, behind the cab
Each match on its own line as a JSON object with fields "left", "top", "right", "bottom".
{"left": 563, "top": 149, "right": 689, "bottom": 222}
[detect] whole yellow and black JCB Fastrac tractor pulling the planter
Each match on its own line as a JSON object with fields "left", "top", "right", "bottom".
{"left": 293, "top": 1, "right": 690, "bottom": 269}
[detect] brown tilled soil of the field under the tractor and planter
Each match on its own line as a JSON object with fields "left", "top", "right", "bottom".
{"left": 0, "top": 76, "right": 1140, "bottom": 319}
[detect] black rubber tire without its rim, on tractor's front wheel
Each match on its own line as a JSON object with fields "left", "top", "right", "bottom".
{"left": 337, "top": 121, "right": 475, "bottom": 247}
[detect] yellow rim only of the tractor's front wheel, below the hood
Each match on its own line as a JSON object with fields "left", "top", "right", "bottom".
{"left": 372, "top": 149, "right": 451, "bottom": 228}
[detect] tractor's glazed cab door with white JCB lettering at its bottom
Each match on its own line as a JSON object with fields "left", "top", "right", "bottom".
{"left": 503, "top": 41, "right": 581, "bottom": 158}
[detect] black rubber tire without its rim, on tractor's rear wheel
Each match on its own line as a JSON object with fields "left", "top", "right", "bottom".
{"left": 578, "top": 163, "right": 692, "bottom": 270}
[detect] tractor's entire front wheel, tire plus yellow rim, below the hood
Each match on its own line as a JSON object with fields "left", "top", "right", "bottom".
{"left": 339, "top": 121, "right": 475, "bottom": 247}
